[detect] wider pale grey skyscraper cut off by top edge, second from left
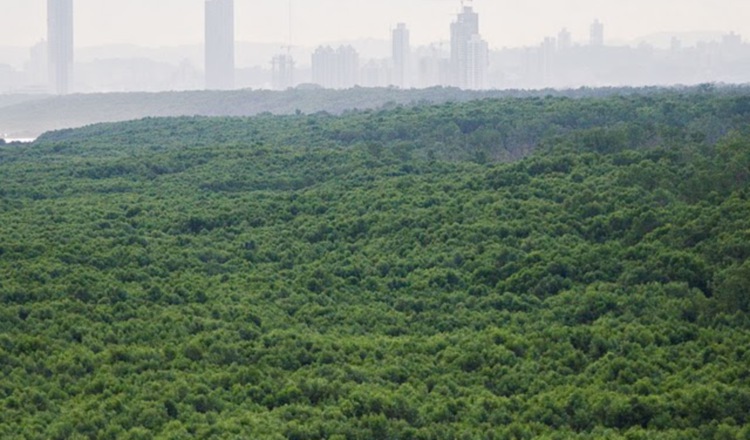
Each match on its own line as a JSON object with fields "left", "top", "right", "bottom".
{"left": 205, "top": 0, "right": 234, "bottom": 90}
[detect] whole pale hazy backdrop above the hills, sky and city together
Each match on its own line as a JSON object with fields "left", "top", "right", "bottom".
{"left": 0, "top": 0, "right": 750, "bottom": 94}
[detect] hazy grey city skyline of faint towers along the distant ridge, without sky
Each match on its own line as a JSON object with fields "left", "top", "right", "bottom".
{"left": 0, "top": 0, "right": 750, "bottom": 94}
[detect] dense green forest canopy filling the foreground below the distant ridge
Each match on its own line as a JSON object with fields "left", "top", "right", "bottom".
{"left": 0, "top": 89, "right": 750, "bottom": 439}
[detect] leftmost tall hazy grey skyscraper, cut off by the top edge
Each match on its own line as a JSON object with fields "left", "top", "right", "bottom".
{"left": 47, "top": 0, "right": 73, "bottom": 95}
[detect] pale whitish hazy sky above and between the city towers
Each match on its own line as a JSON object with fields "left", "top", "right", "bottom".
{"left": 0, "top": 0, "right": 750, "bottom": 48}
